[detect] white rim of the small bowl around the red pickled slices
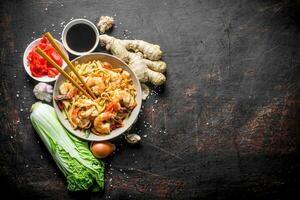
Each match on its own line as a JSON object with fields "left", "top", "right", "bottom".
{"left": 23, "top": 38, "right": 69, "bottom": 82}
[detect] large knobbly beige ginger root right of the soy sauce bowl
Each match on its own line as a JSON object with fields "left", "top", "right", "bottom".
{"left": 99, "top": 35, "right": 166, "bottom": 85}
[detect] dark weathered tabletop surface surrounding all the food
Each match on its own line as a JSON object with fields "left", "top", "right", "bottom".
{"left": 0, "top": 0, "right": 300, "bottom": 200}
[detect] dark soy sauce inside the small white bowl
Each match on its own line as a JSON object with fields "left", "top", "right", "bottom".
{"left": 66, "top": 24, "right": 96, "bottom": 52}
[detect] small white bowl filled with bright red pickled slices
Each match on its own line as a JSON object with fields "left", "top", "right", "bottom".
{"left": 23, "top": 36, "right": 68, "bottom": 82}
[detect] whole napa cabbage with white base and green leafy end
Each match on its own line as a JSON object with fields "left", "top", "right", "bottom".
{"left": 30, "top": 102, "right": 104, "bottom": 192}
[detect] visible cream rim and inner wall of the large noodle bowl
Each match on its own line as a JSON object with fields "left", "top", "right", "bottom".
{"left": 53, "top": 53, "right": 142, "bottom": 141}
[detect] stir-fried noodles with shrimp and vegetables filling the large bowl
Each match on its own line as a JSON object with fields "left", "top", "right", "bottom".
{"left": 55, "top": 60, "right": 137, "bottom": 134}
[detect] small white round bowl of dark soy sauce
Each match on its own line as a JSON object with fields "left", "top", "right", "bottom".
{"left": 62, "top": 19, "right": 99, "bottom": 56}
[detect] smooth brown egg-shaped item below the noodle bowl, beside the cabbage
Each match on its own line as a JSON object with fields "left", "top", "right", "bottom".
{"left": 90, "top": 141, "right": 116, "bottom": 158}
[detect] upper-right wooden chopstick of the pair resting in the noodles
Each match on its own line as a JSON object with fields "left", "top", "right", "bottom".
{"left": 45, "top": 32, "right": 96, "bottom": 99}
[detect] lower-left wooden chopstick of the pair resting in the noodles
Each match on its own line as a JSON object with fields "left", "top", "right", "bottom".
{"left": 35, "top": 47, "right": 92, "bottom": 99}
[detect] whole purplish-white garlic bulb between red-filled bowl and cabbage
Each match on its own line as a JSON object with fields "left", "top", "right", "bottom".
{"left": 33, "top": 83, "right": 53, "bottom": 102}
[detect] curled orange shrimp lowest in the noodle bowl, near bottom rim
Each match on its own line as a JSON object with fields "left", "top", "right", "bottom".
{"left": 92, "top": 112, "right": 114, "bottom": 134}
